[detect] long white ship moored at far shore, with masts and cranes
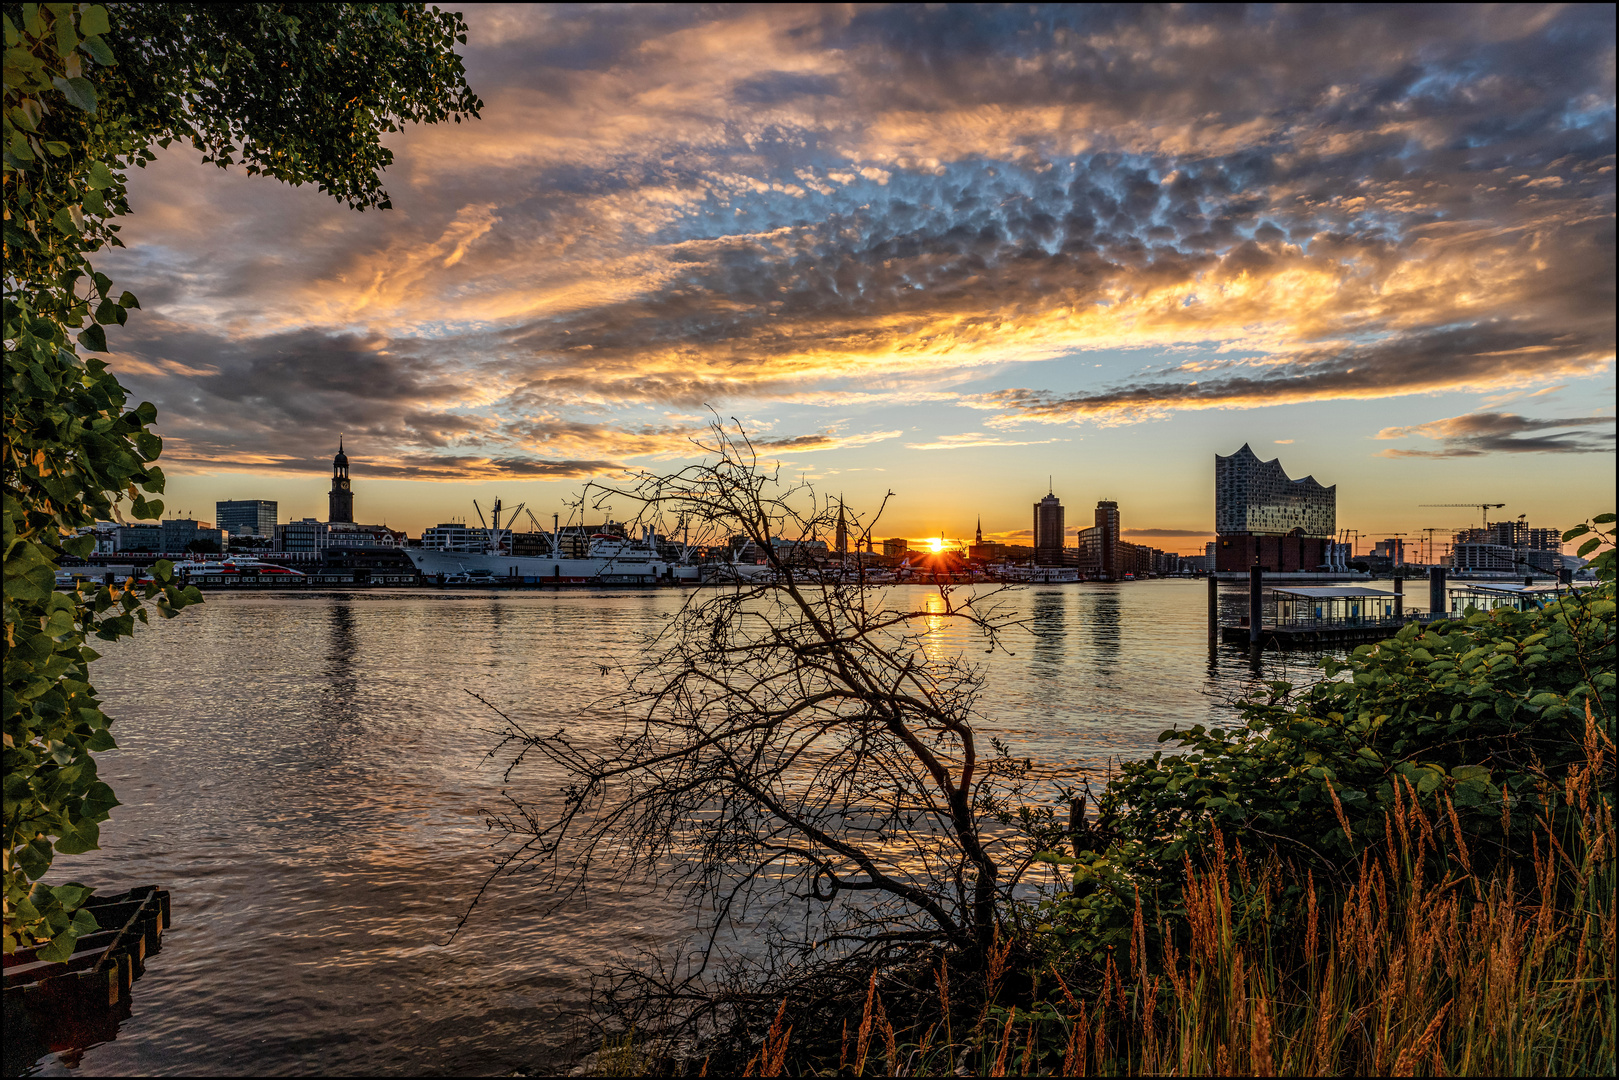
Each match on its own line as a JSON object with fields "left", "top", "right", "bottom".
{"left": 405, "top": 500, "right": 698, "bottom": 585}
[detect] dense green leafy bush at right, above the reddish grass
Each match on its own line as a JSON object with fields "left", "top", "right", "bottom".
{"left": 1036, "top": 515, "right": 1614, "bottom": 963}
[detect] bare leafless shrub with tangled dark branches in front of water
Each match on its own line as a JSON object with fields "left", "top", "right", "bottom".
{"left": 472, "top": 424, "right": 1028, "bottom": 975}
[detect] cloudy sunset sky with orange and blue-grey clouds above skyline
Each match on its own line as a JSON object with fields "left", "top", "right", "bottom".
{"left": 97, "top": 5, "right": 1616, "bottom": 554}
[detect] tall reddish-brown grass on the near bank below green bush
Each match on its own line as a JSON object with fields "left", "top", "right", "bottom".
{"left": 722, "top": 709, "right": 1619, "bottom": 1077}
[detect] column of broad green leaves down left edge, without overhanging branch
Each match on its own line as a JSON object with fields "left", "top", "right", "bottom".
{"left": 3, "top": 5, "right": 202, "bottom": 959}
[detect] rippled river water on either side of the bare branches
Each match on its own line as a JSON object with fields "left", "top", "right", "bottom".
{"left": 25, "top": 581, "right": 1359, "bottom": 1075}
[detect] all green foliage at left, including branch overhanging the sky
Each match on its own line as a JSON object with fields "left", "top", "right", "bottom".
{"left": 0, "top": 3, "right": 482, "bottom": 959}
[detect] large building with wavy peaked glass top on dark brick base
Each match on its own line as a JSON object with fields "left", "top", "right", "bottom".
{"left": 1214, "top": 444, "right": 1337, "bottom": 573}
